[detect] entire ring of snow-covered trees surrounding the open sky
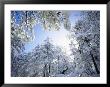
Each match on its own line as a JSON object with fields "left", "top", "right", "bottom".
{"left": 11, "top": 10, "right": 100, "bottom": 77}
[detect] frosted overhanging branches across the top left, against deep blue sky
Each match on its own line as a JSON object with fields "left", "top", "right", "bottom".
{"left": 11, "top": 10, "right": 71, "bottom": 41}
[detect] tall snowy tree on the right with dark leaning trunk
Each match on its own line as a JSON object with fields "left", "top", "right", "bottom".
{"left": 71, "top": 11, "right": 100, "bottom": 76}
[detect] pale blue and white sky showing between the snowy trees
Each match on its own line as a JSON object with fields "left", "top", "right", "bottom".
{"left": 25, "top": 11, "right": 80, "bottom": 55}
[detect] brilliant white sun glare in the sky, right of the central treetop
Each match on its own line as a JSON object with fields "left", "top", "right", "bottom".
{"left": 48, "top": 29, "right": 71, "bottom": 55}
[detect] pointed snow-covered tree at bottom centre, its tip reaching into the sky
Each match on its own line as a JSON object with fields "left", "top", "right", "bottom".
{"left": 24, "top": 38, "right": 68, "bottom": 77}
